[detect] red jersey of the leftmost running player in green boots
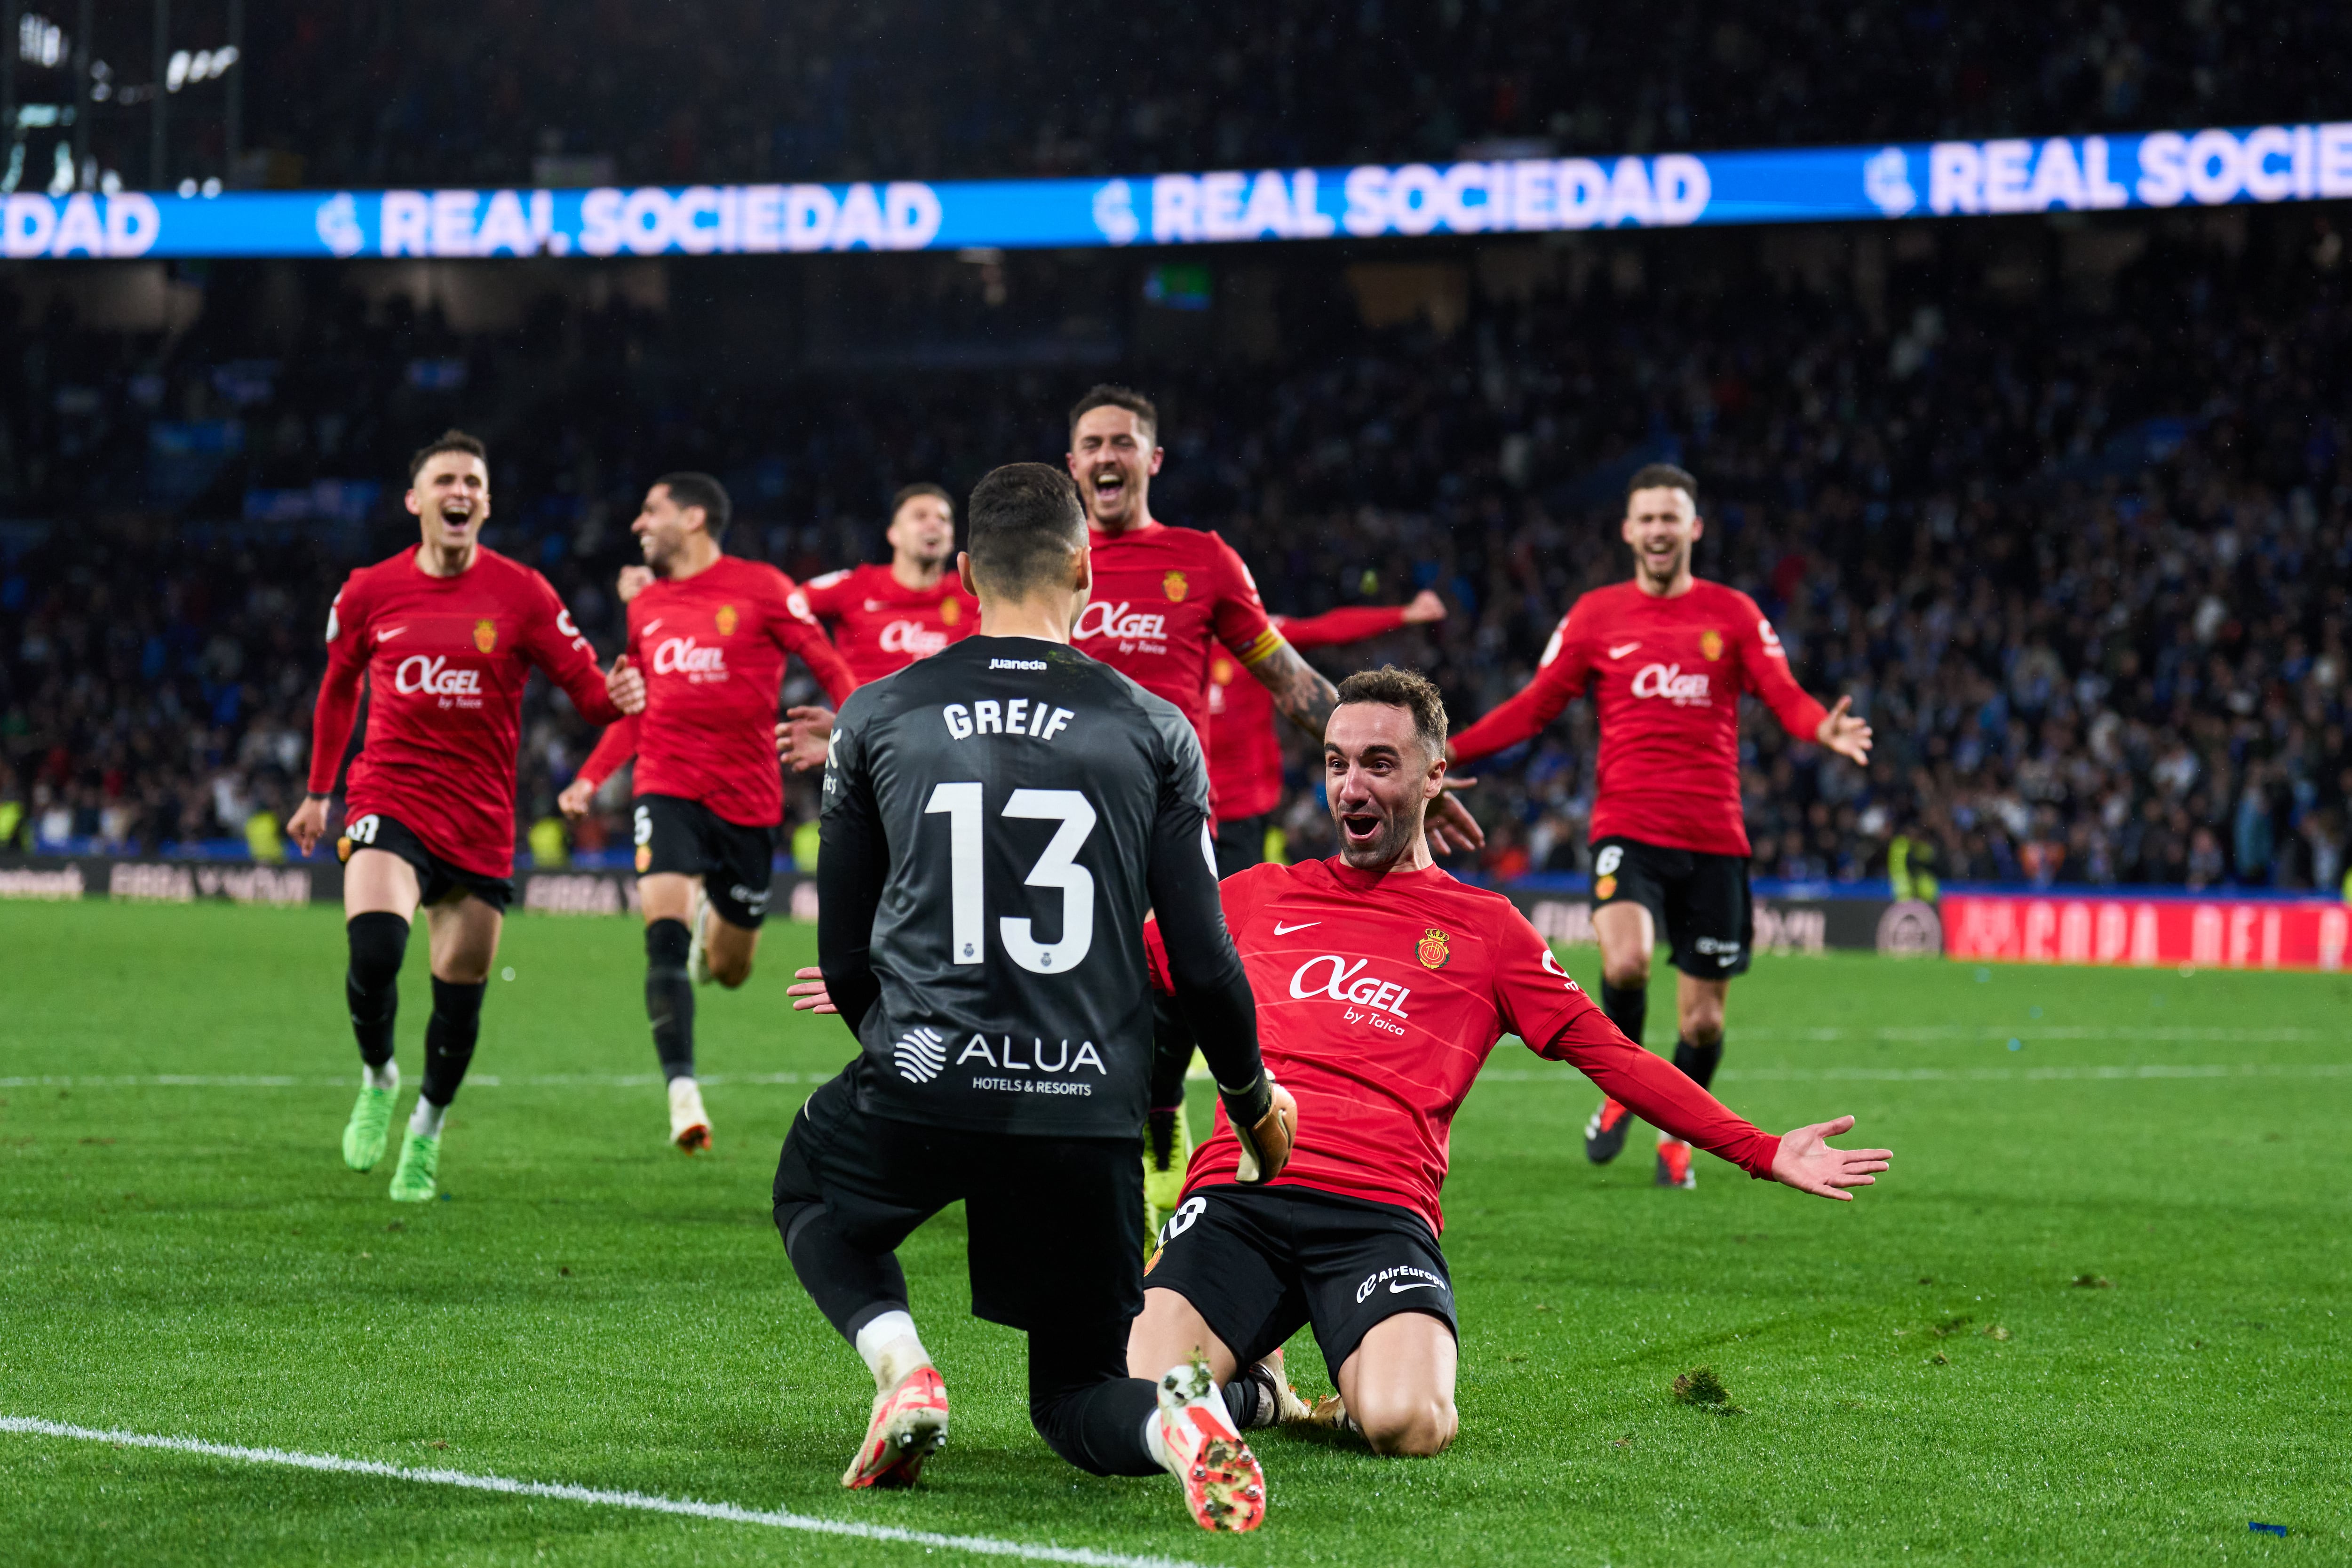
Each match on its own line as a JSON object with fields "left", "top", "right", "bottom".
{"left": 310, "top": 548, "right": 621, "bottom": 877}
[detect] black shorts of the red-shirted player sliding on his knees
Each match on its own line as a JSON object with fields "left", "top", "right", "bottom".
{"left": 1143, "top": 1182, "right": 1461, "bottom": 1380}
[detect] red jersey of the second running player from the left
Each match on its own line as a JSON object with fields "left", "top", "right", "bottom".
{"left": 581, "top": 555, "right": 858, "bottom": 828}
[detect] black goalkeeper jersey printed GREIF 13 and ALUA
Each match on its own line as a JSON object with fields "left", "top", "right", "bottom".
{"left": 818, "top": 637, "right": 1258, "bottom": 1138}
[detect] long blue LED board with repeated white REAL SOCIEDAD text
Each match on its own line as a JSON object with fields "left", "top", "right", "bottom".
{"left": 0, "top": 122, "right": 2352, "bottom": 259}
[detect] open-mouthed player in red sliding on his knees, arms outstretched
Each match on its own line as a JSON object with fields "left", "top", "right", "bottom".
{"left": 1129, "top": 668, "right": 1889, "bottom": 1455}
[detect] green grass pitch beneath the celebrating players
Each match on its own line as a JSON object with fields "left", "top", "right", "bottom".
{"left": 0, "top": 903, "right": 2352, "bottom": 1566}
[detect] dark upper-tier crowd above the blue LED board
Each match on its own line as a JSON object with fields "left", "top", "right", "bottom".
{"left": 216, "top": 0, "right": 2343, "bottom": 186}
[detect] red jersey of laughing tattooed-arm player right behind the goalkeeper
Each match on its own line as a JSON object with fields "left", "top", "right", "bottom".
{"left": 1070, "top": 522, "right": 1282, "bottom": 816}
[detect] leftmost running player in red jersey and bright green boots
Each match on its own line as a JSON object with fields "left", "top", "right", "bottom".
{"left": 287, "top": 430, "right": 640, "bottom": 1203}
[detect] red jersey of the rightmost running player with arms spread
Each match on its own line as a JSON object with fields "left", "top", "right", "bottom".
{"left": 1454, "top": 581, "right": 1828, "bottom": 856}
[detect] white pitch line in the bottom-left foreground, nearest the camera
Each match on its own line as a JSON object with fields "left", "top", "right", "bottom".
{"left": 0, "top": 1415, "right": 1200, "bottom": 1568}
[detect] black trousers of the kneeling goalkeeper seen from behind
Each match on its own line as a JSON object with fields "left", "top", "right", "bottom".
{"left": 774, "top": 1063, "right": 1160, "bottom": 1476}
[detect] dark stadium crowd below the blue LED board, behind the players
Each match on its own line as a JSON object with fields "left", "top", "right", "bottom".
{"left": 0, "top": 214, "right": 2352, "bottom": 886}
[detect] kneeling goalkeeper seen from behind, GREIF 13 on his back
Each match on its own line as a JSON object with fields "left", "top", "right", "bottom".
{"left": 776, "top": 463, "right": 1294, "bottom": 1530}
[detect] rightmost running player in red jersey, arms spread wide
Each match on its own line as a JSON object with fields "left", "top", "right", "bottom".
{"left": 1446, "top": 463, "right": 1870, "bottom": 1187}
